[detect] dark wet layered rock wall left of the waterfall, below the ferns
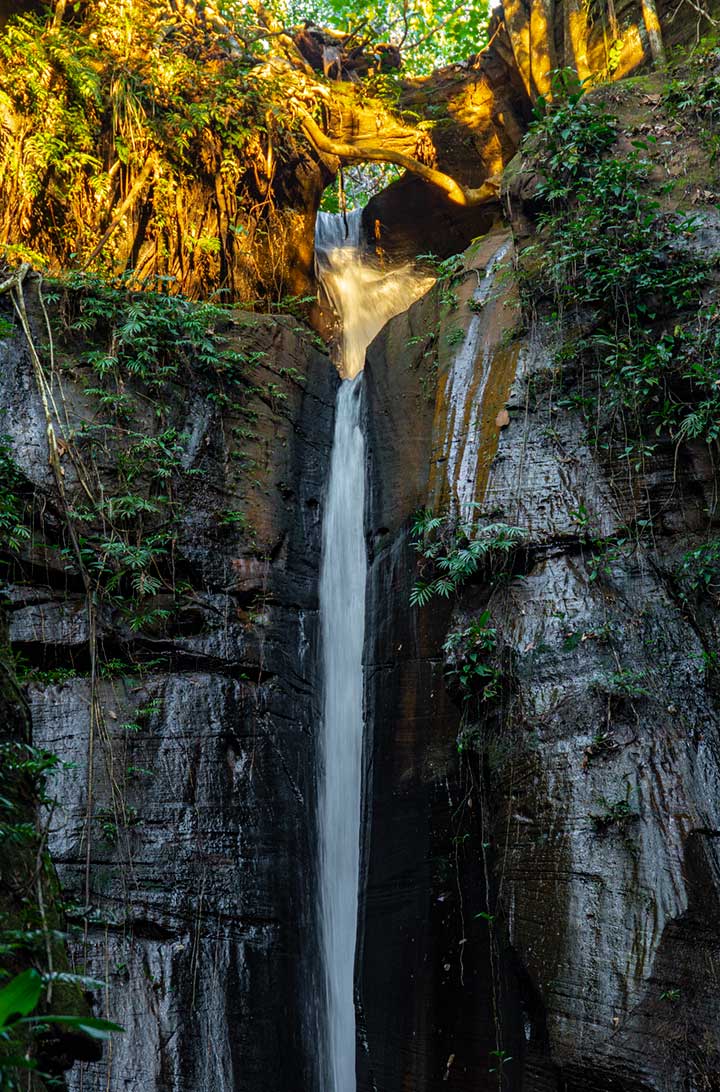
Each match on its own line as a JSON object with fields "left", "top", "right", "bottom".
{"left": 2, "top": 307, "right": 337, "bottom": 1092}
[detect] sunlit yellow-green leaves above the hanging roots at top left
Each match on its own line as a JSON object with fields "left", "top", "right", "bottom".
{"left": 0, "top": 2, "right": 281, "bottom": 181}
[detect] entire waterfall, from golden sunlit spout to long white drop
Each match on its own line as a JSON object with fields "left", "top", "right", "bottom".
{"left": 316, "top": 210, "right": 432, "bottom": 1092}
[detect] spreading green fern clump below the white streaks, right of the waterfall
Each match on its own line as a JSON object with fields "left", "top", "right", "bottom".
{"left": 410, "top": 509, "right": 526, "bottom": 606}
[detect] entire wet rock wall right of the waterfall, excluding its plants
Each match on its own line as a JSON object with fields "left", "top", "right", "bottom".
{"left": 361, "top": 217, "right": 720, "bottom": 1092}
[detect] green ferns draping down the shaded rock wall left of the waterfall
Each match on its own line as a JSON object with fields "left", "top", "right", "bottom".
{"left": 23, "top": 274, "right": 262, "bottom": 631}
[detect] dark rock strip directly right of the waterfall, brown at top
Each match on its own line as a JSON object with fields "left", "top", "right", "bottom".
{"left": 358, "top": 235, "right": 512, "bottom": 1092}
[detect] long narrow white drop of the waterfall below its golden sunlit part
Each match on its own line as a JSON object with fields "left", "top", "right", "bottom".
{"left": 319, "top": 376, "right": 367, "bottom": 1092}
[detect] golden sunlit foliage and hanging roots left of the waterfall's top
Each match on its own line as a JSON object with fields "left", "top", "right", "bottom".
{"left": 0, "top": 0, "right": 307, "bottom": 298}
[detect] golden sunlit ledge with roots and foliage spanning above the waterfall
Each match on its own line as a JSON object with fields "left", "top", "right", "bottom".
{"left": 0, "top": 0, "right": 717, "bottom": 304}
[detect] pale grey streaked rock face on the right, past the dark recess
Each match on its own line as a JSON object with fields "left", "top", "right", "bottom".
{"left": 488, "top": 334, "right": 720, "bottom": 1090}
